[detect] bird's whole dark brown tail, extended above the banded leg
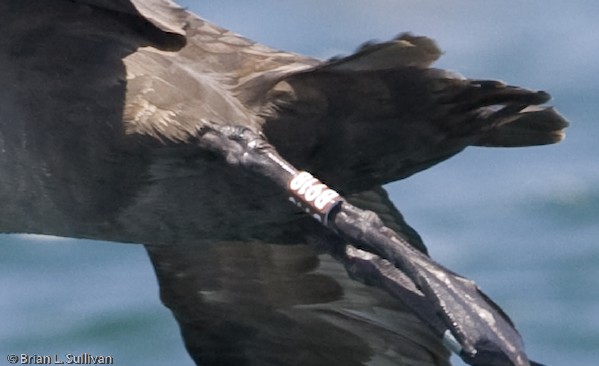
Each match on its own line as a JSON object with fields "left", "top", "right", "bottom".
{"left": 262, "top": 34, "right": 568, "bottom": 193}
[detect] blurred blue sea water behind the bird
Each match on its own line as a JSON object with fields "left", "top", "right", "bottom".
{"left": 0, "top": 0, "right": 599, "bottom": 366}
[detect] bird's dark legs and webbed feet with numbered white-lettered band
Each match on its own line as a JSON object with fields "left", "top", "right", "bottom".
{"left": 198, "top": 122, "right": 530, "bottom": 366}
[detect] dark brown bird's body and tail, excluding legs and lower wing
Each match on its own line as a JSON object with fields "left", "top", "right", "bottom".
{"left": 0, "top": 0, "right": 567, "bottom": 366}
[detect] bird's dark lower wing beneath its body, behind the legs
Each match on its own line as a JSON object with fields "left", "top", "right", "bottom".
{"left": 146, "top": 188, "right": 448, "bottom": 366}
